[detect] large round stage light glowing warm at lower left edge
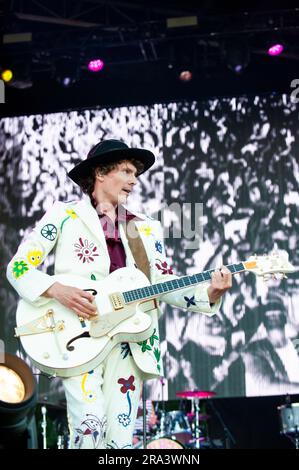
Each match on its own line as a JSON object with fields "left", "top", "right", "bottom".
{"left": 0, "top": 353, "right": 37, "bottom": 449}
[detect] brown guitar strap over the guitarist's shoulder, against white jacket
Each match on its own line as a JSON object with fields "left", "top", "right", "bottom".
{"left": 124, "top": 220, "right": 151, "bottom": 281}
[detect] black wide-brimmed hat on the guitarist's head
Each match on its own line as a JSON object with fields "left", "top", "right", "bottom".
{"left": 68, "top": 139, "right": 155, "bottom": 184}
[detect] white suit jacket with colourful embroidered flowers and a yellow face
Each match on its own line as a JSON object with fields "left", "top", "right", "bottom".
{"left": 7, "top": 198, "right": 220, "bottom": 378}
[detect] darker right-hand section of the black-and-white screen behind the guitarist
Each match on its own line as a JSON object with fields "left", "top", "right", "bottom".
{"left": 157, "top": 96, "right": 299, "bottom": 398}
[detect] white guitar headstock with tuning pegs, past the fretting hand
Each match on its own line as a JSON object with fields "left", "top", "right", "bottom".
{"left": 243, "top": 249, "right": 296, "bottom": 279}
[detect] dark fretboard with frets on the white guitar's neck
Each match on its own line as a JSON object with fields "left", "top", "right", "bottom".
{"left": 123, "top": 263, "right": 245, "bottom": 303}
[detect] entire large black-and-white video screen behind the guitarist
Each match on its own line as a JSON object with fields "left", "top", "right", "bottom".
{"left": 0, "top": 94, "right": 299, "bottom": 400}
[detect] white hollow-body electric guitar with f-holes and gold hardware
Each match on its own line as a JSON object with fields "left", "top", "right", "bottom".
{"left": 15, "top": 251, "right": 295, "bottom": 377}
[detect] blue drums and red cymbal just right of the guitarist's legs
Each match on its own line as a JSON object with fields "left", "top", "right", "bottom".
{"left": 135, "top": 390, "right": 215, "bottom": 449}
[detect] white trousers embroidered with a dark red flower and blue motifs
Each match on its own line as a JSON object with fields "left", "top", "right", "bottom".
{"left": 63, "top": 343, "right": 144, "bottom": 449}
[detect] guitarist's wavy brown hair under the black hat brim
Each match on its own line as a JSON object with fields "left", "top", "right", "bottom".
{"left": 78, "top": 158, "right": 144, "bottom": 207}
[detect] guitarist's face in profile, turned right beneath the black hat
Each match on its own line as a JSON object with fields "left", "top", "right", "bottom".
{"left": 94, "top": 161, "right": 137, "bottom": 206}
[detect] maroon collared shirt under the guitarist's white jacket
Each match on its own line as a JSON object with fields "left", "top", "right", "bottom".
{"left": 99, "top": 208, "right": 138, "bottom": 273}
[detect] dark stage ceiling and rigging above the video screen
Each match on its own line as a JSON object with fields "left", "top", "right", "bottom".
{"left": 0, "top": 0, "right": 299, "bottom": 115}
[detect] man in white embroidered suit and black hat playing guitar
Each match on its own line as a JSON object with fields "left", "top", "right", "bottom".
{"left": 7, "top": 140, "right": 232, "bottom": 448}
